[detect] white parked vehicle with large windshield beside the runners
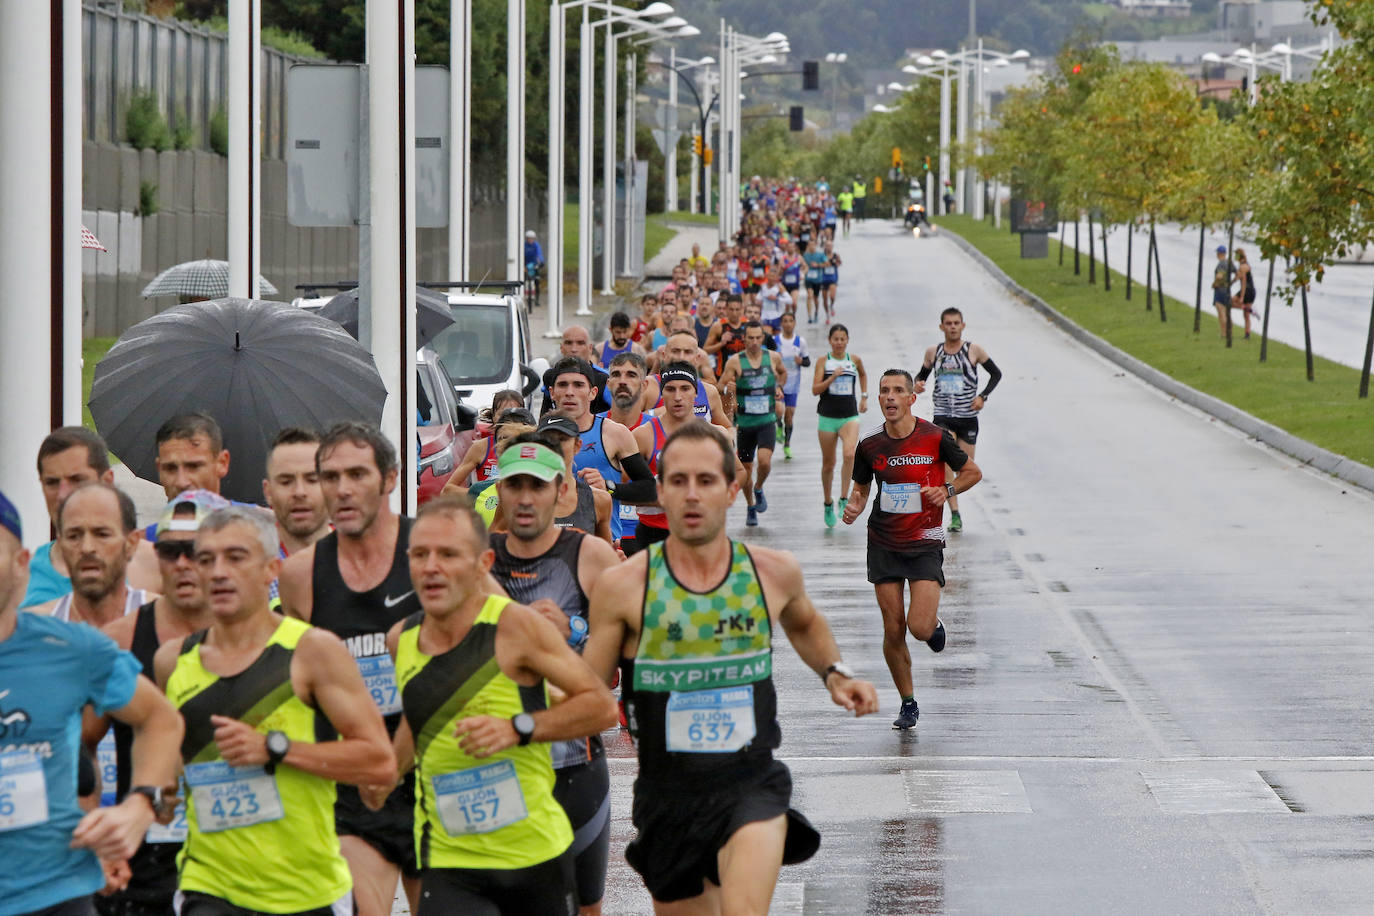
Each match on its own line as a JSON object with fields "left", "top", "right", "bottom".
{"left": 430, "top": 290, "right": 548, "bottom": 409}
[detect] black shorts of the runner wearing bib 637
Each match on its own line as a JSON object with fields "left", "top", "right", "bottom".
{"left": 625, "top": 759, "right": 820, "bottom": 904}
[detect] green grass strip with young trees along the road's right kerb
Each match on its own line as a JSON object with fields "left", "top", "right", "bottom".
{"left": 938, "top": 216, "right": 1374, "bottom": 464}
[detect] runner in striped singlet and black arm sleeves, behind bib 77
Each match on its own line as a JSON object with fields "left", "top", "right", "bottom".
{"left": 916, "top": 308, "right": 1002, "bottom": 534}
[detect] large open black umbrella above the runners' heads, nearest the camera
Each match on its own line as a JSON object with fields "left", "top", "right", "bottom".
{"left": 91, "top": 299, "right": 386, "bottom": 503}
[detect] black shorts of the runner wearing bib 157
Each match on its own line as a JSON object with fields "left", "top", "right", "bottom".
{"left": 415, "top": 849, "right": 577, "bottom": 916}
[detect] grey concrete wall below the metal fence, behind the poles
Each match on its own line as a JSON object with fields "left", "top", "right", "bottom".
{"left": 81, "top": 141, "right": 544, "bottom": 336}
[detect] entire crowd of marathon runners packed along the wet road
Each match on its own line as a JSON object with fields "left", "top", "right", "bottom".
{"left": 0, "top": 173, "right": 1000, "bottom": 916}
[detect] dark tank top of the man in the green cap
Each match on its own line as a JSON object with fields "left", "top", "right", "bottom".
{"left": 492, "top": 529, "right": 603, "bottom": 769}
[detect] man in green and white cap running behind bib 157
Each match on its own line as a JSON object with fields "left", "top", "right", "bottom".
{"left": 491, "top": 444, "right": 612, "bottom": 916}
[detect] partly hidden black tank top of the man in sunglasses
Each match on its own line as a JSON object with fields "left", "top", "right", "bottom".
{"left": 110, "top": 602, "right": 185, "bottom": 906}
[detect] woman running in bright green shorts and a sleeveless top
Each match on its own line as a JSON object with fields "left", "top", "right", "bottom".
{"left": 811, "top": 324, "right": 868, "bottom": 527}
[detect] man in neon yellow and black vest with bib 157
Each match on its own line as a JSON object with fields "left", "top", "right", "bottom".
{"left": 368, "top": 497, "right": 616, "bottom": 916}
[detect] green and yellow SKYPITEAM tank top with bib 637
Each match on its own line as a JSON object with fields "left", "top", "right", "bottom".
{"left": 621, "top": 541, "right": 782, "bottom": 786}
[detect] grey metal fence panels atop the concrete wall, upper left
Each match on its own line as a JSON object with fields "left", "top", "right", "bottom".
{"left": 81, "top": 3, "right": 304, "bottom": 159}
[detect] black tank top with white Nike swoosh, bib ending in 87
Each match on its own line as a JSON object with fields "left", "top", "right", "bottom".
{"left": 311, "top": 516, "right": 420, "bottom": 736}
